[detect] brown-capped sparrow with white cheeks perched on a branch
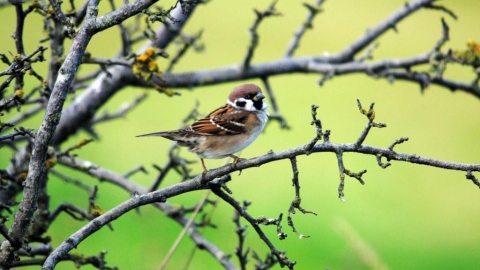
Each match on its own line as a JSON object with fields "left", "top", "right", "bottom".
{"left": 137, "top": 84, "right": 268, "bottom": 174}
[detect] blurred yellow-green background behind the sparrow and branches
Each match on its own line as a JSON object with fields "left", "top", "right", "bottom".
{"left": 0, "top": 0, "right": 480, "bottom": 269}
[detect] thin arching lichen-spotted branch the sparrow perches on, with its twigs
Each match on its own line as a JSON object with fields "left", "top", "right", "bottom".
{"left": 44, "top": 99, "right": 480, "bottom": 269}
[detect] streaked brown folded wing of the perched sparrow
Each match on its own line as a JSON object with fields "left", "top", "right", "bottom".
{"left": 190, "top": 104, "right": 251, "bottom": 136}
